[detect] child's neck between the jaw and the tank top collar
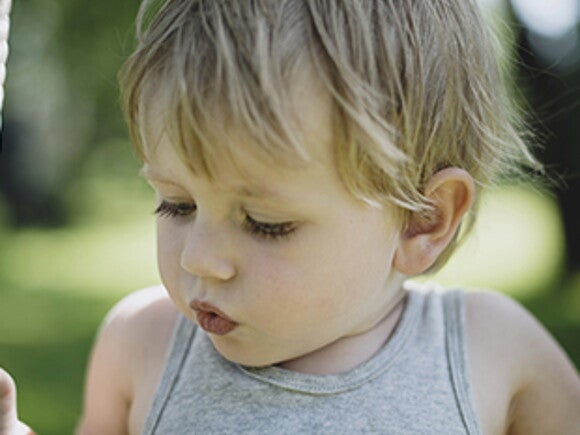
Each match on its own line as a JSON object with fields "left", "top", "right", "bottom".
{"left": 278, "top": 288, "right": 407, "bottom": 375}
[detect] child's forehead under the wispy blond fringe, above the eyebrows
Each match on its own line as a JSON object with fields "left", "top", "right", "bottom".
{"left": 141, "top": 68, "right": 334, "bottom": 172}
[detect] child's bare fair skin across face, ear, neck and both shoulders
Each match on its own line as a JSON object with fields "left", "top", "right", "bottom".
{"left": 1, "top": 80, "right": 580, "bottom": 435}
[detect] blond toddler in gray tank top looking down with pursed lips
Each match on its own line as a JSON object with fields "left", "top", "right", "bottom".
{"left": 1, "top": 0, "right": 580, "bottom": 435}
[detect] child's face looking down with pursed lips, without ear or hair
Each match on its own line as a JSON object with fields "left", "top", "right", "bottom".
{"left": 144, "top": 84, "right": 403, "bottom": 366}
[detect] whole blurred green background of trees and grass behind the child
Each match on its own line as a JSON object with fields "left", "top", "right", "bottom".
{"left": 0, "top": 0, "right": 580, "bottom": 435}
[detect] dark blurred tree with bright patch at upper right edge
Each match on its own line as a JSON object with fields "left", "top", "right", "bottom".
{"left": 509, "top": 0, "right": 580, "bottom": 275}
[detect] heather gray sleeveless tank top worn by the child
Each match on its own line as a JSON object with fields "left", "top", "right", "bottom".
{"left": 143, "top": 289, "right": 480, "bottom": 435}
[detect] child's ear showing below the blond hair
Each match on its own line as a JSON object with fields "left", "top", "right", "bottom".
{"left": 393, "top": 168, "right": 475, "bottom": 275}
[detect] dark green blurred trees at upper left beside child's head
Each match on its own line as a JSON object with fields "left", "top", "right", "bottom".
{"left": 0, "top": 0, "right": 139, "bottom": 225}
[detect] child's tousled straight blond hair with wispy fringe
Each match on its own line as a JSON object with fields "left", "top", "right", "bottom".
{"left": 120, "top": 0, "right": 541, "bottom": 272}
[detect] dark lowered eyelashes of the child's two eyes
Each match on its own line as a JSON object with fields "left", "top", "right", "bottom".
{"left": 154, "top": 201, "right": 296, "bottom": 240}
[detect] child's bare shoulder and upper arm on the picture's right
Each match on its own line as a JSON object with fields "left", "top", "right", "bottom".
{"left": 466, "top": 292, "right": 580, "bottom": 435}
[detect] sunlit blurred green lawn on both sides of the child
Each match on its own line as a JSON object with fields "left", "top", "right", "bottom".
{"left": 0, "top": 178, "right": 580, "bottom": 435}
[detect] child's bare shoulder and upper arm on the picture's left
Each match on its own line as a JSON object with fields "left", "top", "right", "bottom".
{"left": 77, "top": 286, "right": 177, "bottom": 435}
